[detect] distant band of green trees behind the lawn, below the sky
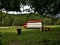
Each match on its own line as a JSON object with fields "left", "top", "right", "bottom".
{"left": 0, "top": 12, "right": 60, "bottom": 26}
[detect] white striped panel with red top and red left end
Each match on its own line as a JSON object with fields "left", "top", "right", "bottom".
{"left": 24, "top": 20, "right": 42, "bottom": 28}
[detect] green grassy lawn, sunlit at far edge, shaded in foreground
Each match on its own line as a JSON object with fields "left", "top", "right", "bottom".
{"left": 0, "top": 26, "right": 60, "bottom": 45}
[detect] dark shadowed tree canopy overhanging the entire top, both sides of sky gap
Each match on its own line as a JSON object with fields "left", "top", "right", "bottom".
{"left": 0, "top": 0, "right": 60, "bottom": 17}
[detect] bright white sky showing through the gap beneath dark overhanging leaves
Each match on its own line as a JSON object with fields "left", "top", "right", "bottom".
{"left": 4, "top": 5, "right": 34, "bottom": 14}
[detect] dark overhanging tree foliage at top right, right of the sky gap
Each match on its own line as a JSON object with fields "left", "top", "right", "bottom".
{"left": 21, "top": 0, "right": 60, "bottom": 18}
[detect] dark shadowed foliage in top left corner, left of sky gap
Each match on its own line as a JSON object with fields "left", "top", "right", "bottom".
{"left": 0, "top": 0, "right": 20, "bottom": 11}
